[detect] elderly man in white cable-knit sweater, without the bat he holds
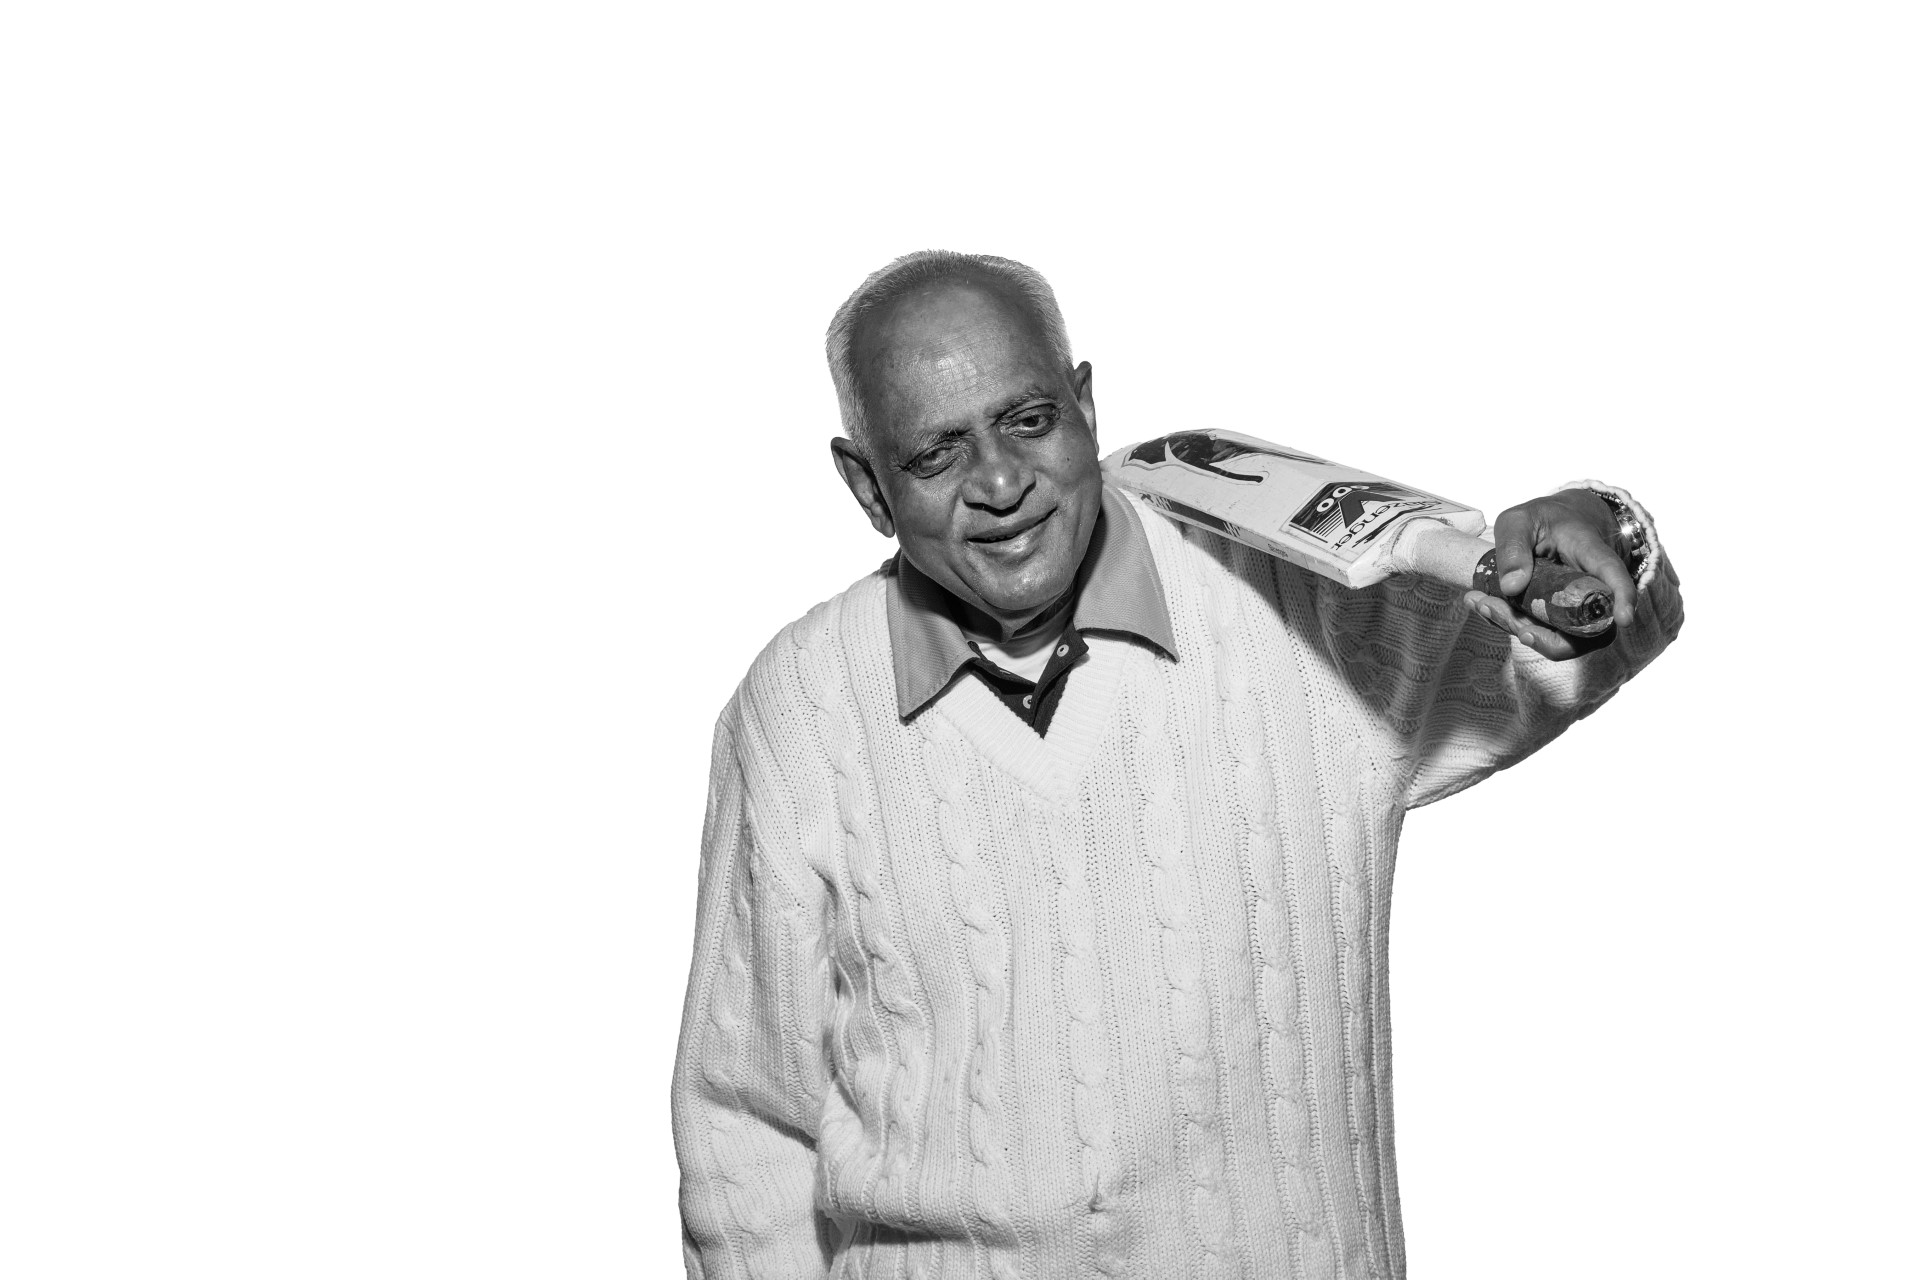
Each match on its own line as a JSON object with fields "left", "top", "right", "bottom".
{"left": 672, "top": 253, "right": 1680, "bottom": 1280}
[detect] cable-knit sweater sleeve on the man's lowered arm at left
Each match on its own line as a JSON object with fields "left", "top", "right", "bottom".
{"left": 672, "top": 716, "right": 829, "bottom": 1280}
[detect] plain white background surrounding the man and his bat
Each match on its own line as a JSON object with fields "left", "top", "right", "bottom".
{"left": 0, "top": 0, "right": 1920, "bottom": 1280}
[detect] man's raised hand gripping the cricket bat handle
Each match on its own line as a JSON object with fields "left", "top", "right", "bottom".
{"left": 1467, "top": 489, "right": 1636, "bottom": 662}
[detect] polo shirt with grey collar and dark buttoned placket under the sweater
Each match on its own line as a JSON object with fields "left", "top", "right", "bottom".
{"left": 887, "top": 486, "right": 1179, "bottom": 735}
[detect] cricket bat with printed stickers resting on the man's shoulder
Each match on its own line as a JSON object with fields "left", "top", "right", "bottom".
{"left": 1100, "top": 430, "right": 1613, "bottom": 639}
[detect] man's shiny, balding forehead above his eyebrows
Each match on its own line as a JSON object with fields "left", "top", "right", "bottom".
{"left": 852, "top": 280, "right": 1066, "bottom": 449}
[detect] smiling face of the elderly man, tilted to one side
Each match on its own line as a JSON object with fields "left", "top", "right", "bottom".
{"left": 843, "top": 280, "right": 1100, "bottom": 631}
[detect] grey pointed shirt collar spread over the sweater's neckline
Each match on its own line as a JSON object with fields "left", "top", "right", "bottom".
{"left": 887, "top": 484, "right": 1179, "bottom": 720}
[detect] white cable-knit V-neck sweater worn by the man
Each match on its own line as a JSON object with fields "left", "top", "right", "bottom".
{"left": 672, "top": 487, "right": 1682, "bottom": 1280}
